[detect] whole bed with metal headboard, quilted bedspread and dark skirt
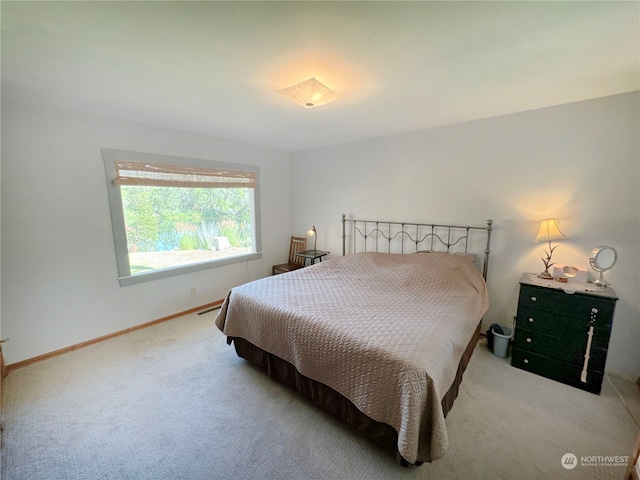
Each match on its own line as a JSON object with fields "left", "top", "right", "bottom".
{"left": 216, "top": 215, "right": 493, "bottom": 465}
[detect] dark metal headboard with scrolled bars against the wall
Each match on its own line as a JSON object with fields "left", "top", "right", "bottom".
{"left": 342, "top": 213, "right": 493, "bottom": 280}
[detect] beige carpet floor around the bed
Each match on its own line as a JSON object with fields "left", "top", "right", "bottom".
{"left": 1, "top": 311, "right": 640, "bottom": 480}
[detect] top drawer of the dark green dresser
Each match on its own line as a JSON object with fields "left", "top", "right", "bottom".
{"left": 518, "top": 285, "right": 615, "bottom": 324}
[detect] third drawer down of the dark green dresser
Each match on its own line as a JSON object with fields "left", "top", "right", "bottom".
{"left": 513, "top": 329, "right": 609, "bottom": 372}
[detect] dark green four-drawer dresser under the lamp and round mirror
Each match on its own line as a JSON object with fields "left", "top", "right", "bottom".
{"left": 511, "top": 273, "right": 618, "bottom": 394}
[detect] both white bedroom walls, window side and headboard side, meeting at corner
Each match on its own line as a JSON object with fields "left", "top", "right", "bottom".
{"left": 1, "top": 92, "right": 640, "bottom": 378}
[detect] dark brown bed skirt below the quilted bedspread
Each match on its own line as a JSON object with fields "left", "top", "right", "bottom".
{"left": 227, "top": 323, "right": 480, "bottom": 465}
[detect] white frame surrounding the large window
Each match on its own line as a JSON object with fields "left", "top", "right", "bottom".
{"left": 102, "top": 148, "right": 262, "bottom": 286}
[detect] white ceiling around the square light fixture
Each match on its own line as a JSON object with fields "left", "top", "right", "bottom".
{"left": 1, "top": 1, "right": 640, "bottom": 151}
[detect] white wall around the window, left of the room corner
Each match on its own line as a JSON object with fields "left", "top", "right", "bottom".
{"left": 1, "top": 101, "right": 291, "bottom": 364}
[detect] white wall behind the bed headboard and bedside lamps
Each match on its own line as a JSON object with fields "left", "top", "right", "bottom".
{"left": 292, "top": 92, "right": 640, "bottom": 379}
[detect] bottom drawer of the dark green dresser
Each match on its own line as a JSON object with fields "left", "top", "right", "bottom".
{"left": 511, "top": 347, "right": 604, "bottom": 393}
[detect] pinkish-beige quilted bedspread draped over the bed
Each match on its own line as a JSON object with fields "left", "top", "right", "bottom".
{"left": 216, "top": 253, "right": 488, "bottom": 463}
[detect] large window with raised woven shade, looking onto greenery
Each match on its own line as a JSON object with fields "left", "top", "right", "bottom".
{"left": 102, "top": 149, "right": 261, "bottom": 285}
